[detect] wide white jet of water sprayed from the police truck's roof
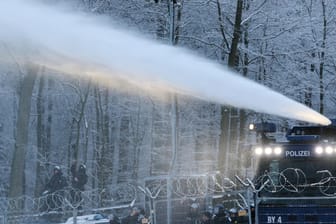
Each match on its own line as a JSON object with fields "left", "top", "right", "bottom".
{"left": 0, "top": 0, "right": 330, "bottom": 125}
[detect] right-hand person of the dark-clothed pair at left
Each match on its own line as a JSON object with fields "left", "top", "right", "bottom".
{"left": 70, "top": 162, "right": 88, "bottom": 206}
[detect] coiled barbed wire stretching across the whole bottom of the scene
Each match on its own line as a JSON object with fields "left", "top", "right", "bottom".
{"left": 0, "top": 168, "right": 336, "bottom": 224}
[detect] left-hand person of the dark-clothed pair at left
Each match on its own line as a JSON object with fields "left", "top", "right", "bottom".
{"left": 43, "top": 166, "right": 68, "bottom": 210}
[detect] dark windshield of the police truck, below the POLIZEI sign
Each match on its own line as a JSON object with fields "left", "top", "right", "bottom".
{"left": 255, "top": 157, "right": 336, "bottom": 197}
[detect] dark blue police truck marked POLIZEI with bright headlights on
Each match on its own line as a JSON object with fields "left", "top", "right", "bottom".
{"left": 253, "top": 121, "right": 336, "bottom": 224}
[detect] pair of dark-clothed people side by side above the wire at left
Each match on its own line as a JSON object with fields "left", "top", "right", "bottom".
{"left": 43, "top": 161, "right": 88, "bottom": 209}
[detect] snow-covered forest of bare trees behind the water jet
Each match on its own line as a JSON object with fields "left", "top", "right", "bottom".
{"left": 0, "top": 0, "right": 336, "bottom": 224}
